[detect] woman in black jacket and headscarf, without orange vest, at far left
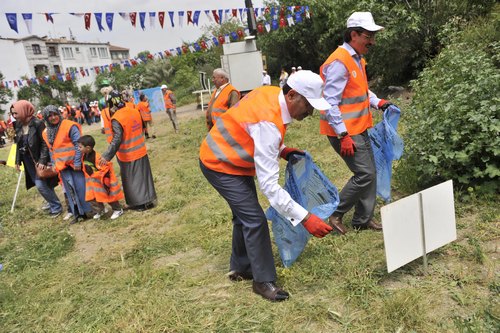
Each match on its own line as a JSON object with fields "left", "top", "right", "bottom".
{"left": 11, "top": 100, "right": 62, "bottom": 217}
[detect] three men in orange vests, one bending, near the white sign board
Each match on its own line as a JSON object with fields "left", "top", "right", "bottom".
{"left": 199, "top": 12, "right": 398, "bottom": 301}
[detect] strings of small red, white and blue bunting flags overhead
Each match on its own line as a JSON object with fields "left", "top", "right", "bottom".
{"left": 0, "top": 6, "right": 311, "bottom": 88}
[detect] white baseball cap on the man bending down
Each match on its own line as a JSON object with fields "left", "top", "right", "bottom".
{"left": 286, "top": 70, "right": 331, "bottom": 110}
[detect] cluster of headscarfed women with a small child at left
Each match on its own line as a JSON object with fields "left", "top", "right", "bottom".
{"left": 10, "top": 87, "right": 167, "bottom": 224}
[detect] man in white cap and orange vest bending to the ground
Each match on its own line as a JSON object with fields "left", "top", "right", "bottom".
{"left": 200, "top": 71, "right": 332, "bottom": 301}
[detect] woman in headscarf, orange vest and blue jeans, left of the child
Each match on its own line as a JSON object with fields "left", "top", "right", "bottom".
{"left": 42, "top": 105, "right": 92, "bottom": 224}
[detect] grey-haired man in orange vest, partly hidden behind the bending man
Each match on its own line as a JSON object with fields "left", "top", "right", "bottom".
{"left": 206, "top": 68, "right": 240, "bottom": 131}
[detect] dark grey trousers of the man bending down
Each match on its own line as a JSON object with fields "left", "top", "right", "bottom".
{"left": 200, "top": 162, "right": 276, "bottom": 282}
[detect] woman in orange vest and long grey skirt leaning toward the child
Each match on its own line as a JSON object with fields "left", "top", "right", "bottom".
{"left": 99, "top": 90, "right": 156, "bottom": 210}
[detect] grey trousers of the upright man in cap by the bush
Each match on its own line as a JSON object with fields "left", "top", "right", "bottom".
{"left": 328, "top": 131, "right": 377, "bottom": 226}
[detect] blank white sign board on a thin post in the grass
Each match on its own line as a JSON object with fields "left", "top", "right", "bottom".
{"left": 380, "top": 180, "right": 457, "bottom": 272}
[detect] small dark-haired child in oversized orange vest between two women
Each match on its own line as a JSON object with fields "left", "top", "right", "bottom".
{"left": 78, "top": 135, "right": 124, "bottom": 220}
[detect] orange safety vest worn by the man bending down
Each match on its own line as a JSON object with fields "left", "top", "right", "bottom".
{"left": 200, "top": 86, "right": 286, "bottom": 176}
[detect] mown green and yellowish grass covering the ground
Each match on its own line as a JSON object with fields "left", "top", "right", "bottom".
{"left": 0, "top": 107, "right": 500, "bottom": 332}
